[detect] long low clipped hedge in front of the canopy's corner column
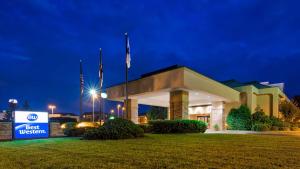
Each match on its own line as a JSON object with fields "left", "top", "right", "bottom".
{"left": 149, "top": 120, "right": 207, "bottom": 133}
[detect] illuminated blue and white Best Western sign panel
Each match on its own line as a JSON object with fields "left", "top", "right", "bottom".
{"left": 14, "top": 111, "right": 49, "bottom": 139}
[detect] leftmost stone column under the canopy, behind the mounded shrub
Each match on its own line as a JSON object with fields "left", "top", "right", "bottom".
{"left": 124, "top": 99, "right": 139, "bottom": 124}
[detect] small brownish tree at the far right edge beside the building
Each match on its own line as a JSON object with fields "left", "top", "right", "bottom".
{"left": 279, "top": 101, "right": 300, "bottom": 122}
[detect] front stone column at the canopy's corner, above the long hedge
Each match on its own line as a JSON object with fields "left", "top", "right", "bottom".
{"left": 170, "top": 90, "right": 189, "bottom": 120}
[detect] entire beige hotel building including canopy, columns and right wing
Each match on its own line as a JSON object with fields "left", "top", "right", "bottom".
{"left": 107, "top": 66, "right": 287, "bottom": 129}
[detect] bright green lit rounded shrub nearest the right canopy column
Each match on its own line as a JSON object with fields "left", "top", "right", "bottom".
{"left": 226, "top": 105, "right": 251, "bottom": 130}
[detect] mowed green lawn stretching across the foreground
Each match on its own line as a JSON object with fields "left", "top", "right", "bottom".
{"left": 0, "top": 134, "right": 300, "bottom": 169}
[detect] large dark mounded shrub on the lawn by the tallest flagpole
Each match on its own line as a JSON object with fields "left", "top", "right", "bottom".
{"left": 83, "top": 118, "right": 144, "bottom": 140}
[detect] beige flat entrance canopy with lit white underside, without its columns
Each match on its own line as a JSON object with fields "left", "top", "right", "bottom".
{"left": 107, "top": 66, "right": 240, "bottom": 107}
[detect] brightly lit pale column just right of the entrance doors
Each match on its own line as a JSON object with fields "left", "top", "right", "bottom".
{"left": 210, "top": 102, "right": 224, "bottom": 130}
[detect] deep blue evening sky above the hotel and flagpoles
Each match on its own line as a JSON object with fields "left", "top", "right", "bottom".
{"left": 0, "top": 0, "right": 300, "bottom": 112}
